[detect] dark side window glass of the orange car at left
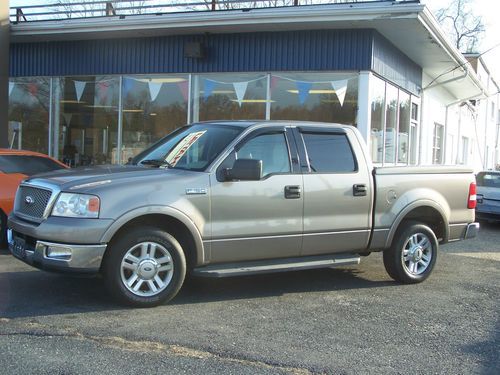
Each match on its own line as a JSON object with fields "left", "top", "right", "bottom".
{"left": 0, "top": 155, "right": 64, "bottom": 176}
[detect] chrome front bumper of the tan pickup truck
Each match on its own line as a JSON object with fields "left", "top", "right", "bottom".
{"left": 7, "top": 229, "right": 106, "bottom": 273}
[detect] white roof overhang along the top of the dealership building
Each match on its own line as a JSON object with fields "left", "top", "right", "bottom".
{"left": 11, "top": 1, "right": 486, "bottom": 101}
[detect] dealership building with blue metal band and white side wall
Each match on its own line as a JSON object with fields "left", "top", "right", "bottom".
{"left": 4, "top": 0, "right": 500, "bottom": 170}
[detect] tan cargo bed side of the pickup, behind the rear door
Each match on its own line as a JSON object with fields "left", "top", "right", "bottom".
{"left": 370, "top": 166, "right": 475, "bottom": 250}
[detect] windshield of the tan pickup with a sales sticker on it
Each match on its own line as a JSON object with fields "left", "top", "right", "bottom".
{"left": 131, "top": 124, "right": 243, "bottom": 171}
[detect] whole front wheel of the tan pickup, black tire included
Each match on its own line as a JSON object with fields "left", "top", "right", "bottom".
{"left": 102, "top": 227, "right": 186, "bottom": 307}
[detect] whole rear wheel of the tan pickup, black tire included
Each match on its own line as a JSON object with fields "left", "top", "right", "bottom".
{"left": 384, "top": 221, "right": 439, "bottom": 284}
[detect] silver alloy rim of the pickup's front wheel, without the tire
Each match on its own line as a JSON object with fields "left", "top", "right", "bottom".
{"left": 120, "top": 241, "right": 174, "bottom": 297}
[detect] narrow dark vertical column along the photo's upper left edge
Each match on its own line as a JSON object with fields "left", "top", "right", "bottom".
{"left": 0, "top": 0, "right": 10, "bottom": 147}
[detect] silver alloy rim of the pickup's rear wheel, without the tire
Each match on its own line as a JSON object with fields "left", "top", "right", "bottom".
{"left": 401, "top": 233, "right": 432, "bottom": 275}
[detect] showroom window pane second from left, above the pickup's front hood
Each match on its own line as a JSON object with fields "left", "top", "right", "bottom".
{"left": 53, "top": 76, "right": 119, "bottom": 167}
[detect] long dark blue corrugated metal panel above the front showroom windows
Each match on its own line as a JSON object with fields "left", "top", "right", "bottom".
{"left": 10, "top": 30, "right": 373, "bottom": 77}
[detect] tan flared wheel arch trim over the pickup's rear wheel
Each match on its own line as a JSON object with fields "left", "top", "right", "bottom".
{"left": 385, "top": 200, "right": 449, "bottom": 248}
